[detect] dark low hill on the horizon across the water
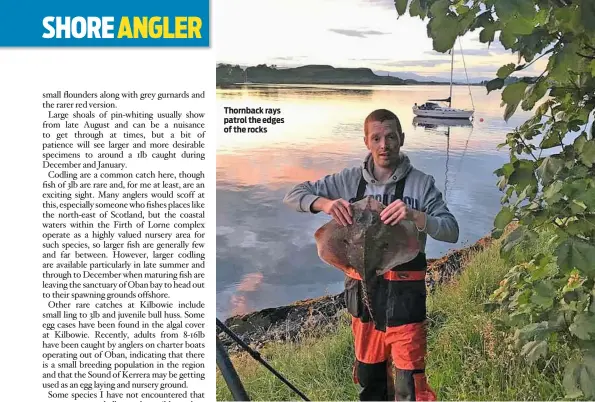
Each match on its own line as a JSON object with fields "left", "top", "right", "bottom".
{"left": 217, "top": 64, "right": 448, "bottom": 85}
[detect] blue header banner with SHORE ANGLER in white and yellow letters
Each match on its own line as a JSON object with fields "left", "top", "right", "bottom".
{"left": 0, "top": 0, "right": 210, "bottom": 47}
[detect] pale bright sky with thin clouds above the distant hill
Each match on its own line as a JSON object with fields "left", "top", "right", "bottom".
{"left": 218, "top": 0, "right": 547, "bottom": 81}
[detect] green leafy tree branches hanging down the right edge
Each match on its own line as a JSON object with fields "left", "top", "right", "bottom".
{"left": 397, "top": 0, "right": 595, "bottom": 398}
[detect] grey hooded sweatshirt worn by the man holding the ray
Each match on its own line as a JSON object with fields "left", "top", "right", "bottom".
{"left": 283, "top": 152, "right": 459, "bottom": 252}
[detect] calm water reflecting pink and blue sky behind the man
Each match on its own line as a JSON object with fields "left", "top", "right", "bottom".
{"left": 217, "top": 85, "right": 528, "bottom": 319}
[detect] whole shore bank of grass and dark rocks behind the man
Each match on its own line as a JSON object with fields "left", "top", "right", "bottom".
{"left": 217, "top": 229, "right": 572, "bottom": 400}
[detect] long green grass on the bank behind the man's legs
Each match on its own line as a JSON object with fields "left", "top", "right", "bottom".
{"left": 217, "top": 234, "right": 569, "bottom": 400}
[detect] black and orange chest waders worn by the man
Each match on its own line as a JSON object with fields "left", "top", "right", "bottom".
{"left": 345, "top": 172, "right": 436, "bottom": 401}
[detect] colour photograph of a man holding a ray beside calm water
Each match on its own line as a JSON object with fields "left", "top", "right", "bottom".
{"left": 216, "top": 0, "right": 595, "bottom": 401}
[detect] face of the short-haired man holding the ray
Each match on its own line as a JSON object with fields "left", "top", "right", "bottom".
{"left": 364, "top": 120, "right": 403, "bottom": 168}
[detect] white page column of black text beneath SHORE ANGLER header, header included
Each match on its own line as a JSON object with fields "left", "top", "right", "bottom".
{"left": 0, "top": 0, "right": 216, "bottom": 401}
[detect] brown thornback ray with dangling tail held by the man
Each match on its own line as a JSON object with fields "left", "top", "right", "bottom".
{"left": 314, "top": 196, "right": 420, "bottom": 321}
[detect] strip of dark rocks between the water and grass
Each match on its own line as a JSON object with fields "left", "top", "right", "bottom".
{"left": 217, "top": 236, "right": 492, "bottom": 353}
